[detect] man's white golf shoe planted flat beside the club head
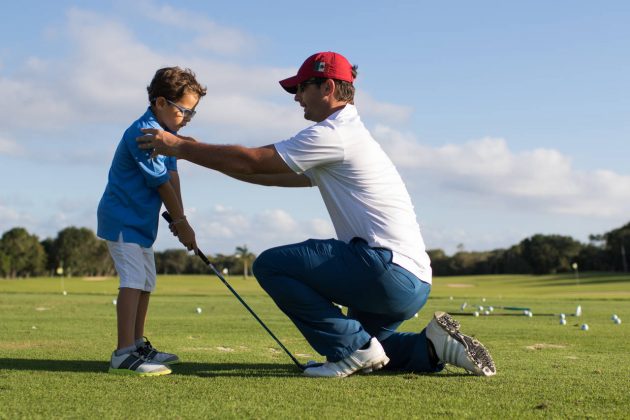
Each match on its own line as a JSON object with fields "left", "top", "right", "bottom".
{"left": 304, "top": 337, "right": 389, "bottom": 378}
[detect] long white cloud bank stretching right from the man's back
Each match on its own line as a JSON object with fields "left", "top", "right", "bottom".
{"left": 374, "top": 125, "right": 630, "bottom": 217}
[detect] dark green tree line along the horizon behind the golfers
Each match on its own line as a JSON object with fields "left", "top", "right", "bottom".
{"left": 0, "top": 223, "right": 630, "bottom": 278}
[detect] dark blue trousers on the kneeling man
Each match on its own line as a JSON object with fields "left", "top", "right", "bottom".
{"left": 253, "top": 238, "right": 443, "bottom": 372}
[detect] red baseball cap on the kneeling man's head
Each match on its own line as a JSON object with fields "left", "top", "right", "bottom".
{"left": 280, "top": 51, "right": 354, "bottom": 94}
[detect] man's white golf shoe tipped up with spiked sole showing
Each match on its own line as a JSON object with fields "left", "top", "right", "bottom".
{"left": 426, "top": 312, "right": 497, "bottom": 376}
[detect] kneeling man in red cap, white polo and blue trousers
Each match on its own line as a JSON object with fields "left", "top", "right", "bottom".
{"left": 138, "top": 52, "right": 496, "bottom": 377}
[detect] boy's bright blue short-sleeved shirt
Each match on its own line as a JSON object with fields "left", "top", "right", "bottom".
{"left": 97, "top": 108, "right": 177, "bottom": 248}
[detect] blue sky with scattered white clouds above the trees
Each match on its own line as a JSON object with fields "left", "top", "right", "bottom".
{"left": 0, "top": 0, "right": 630, "bottom": 254}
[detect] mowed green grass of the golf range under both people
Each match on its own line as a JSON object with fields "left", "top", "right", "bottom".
{"left": 0, "top": 274, "right": 630, "bottom": 419}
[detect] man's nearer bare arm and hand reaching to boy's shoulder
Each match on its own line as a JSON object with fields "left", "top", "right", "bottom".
{"left": 137, "top": 128, "right": 294, "bottom": 175}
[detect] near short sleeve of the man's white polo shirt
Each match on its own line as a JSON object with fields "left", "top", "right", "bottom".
{"left": 274, "top": 125, "right": 344, "bottom": 174}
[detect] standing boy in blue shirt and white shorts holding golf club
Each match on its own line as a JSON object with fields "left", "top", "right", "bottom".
{"left": 97, "top": 67, "right": 206, "bottom": 376}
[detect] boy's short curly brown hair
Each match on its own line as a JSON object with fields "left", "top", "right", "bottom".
{"left": 147, "top": 67, "right": 206, "bottom": 104}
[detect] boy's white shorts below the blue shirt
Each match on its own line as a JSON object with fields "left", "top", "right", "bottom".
{"left": 107, "top": 238, "right": 156, "bottom": 292}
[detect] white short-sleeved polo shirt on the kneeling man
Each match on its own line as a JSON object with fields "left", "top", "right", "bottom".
{"left": 274, "top": 104, "right": 431, "bottom": 283}
